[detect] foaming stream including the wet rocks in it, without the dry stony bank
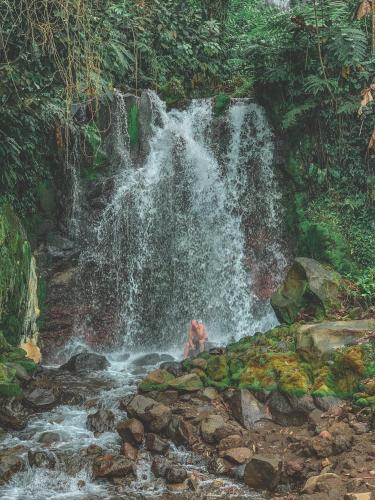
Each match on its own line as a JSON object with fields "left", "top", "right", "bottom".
{"left": 0, "top": 353, "right": 263, "bottom": 500}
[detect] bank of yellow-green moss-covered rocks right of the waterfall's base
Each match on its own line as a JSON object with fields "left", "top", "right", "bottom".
{"left": 140, "top": 323, "right": 375, "bottom": 411}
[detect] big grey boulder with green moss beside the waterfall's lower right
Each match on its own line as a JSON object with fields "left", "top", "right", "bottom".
{"left": 271, "top": 257, "right": 340, "bottom": 323}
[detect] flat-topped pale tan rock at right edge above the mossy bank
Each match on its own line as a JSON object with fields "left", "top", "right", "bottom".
{"left": 296, "top": 319, "right": 375, "bottom": 362}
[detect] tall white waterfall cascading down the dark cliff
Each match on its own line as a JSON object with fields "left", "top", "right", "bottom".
{"left": 78, "top": 91, "right": 286, "bottom": 347}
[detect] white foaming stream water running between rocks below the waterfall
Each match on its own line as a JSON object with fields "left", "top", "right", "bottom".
{"left": 0, "top": 344, "right": 264, "bottom": 500}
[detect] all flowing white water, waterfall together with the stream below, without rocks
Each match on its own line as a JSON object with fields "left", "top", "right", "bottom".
{"left": 0, "top": 92, "right": 286, "bottom": 500}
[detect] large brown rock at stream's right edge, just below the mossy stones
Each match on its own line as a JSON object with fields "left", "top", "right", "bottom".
{"left": 127, "top": 395, "right": 172, "bottom": 432}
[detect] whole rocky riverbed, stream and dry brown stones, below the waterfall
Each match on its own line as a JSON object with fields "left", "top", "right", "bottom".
{"left": 0, "top": 342, "right": 375, "bottom": 500}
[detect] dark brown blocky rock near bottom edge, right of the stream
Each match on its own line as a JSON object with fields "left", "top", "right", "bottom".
{"left": 244, "top": 455, "right": 282, "bottom": 490}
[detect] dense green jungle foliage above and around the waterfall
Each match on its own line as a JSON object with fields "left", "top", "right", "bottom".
{"left": 0, "top": 0, "right": 375, "bottom": 304}
